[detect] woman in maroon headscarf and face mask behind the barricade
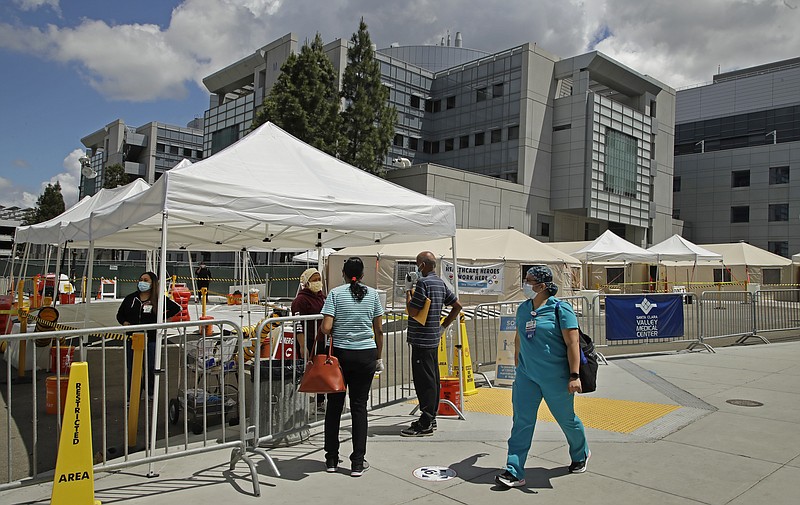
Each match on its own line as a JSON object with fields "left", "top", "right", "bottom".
{"left": 292, "top": 268, "right": 326, "bottom": 413}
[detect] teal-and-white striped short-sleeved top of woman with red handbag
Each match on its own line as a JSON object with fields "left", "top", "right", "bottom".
{"left": 322, "top": 284, "right": 383, "bottom": 350}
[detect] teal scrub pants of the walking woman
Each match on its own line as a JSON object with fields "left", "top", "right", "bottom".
{"left": 506, "top": 372, "right": 589, "bottom": 480}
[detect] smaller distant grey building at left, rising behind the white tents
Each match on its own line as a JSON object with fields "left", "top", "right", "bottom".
{"left": 80, "top": 119, "right": 203, "bottom": 198}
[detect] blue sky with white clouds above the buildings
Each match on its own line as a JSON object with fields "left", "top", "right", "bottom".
{"left": 0, "top": 0, "right": 800, "bottom": 207}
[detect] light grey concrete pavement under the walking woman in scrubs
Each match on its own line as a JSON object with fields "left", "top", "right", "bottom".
{"left": 0, "top": 332, "right": 800, "bottom": 505}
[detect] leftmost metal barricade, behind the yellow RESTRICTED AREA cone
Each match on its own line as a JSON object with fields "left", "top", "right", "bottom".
{"left": 0, "top": 319, "right": 264, "bottom": 495}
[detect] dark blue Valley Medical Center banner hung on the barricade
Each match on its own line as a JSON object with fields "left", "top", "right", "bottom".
{"left": 606, "top": 294, "right": 684, "bottom": 340}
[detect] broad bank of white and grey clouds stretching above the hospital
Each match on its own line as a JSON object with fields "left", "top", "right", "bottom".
{"left": 0, "top": 0, "right": 800, "bottom": 101}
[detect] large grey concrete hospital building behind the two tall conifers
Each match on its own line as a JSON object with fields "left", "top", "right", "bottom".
{"left": 203, "top": 34, "right": 675, "bottom": 245}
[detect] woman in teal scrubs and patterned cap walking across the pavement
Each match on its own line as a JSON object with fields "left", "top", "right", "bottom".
{"left": 495, "top": 265, "right": 591, "bottom": 487}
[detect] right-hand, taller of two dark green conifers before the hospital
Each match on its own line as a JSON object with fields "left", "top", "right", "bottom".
{"left": 340, "top": 18, "right": 397, "bottom": 176}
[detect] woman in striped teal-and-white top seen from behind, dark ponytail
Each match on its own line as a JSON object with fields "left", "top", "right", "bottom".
{"left": 321, "top": 257, "right": 384, "bottom": 477}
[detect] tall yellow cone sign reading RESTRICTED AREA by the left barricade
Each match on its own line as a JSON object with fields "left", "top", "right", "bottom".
{"left": 50, "top": 362, "right": 100, "bottom": 505}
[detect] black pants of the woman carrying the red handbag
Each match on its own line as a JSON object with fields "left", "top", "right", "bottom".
{"left": 325, "top": 347, "right": 378, "bottom": 465}
